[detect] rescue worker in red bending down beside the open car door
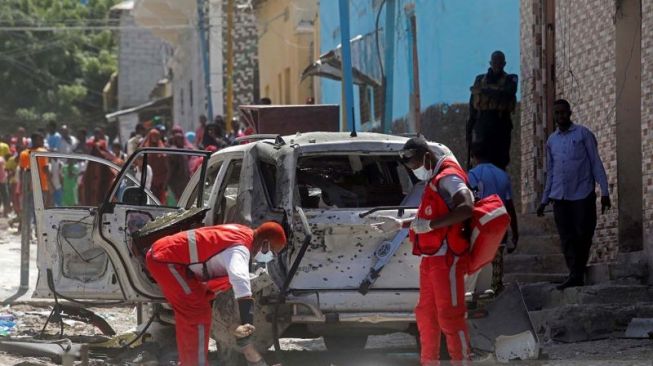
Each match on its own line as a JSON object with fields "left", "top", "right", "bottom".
{"left": 146, "top": 222, "right": 286, "bottom": 366}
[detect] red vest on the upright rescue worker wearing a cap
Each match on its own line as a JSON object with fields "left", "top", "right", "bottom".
{"left": 409, "top": 158, "right": 469, "bottom": 255}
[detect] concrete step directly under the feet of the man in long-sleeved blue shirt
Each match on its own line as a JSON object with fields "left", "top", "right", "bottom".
{"left": 521, "top": 283, "right": 653, "bottom": 311}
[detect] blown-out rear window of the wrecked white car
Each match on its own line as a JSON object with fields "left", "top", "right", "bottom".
{"left": 296, "top": 154, "right": 413, "bottom": 208}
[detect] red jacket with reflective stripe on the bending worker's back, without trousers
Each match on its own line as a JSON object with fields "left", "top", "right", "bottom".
{"left": 150, "top": 224, "right": 254, "bottom": 265}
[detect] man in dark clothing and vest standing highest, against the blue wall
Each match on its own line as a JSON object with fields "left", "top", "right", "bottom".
{"left": 467, "top": 51, "right": 518, "bottom": 170}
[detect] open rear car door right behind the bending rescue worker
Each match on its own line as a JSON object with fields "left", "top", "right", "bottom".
{"left": 94, "top": 148, "right": 210, "bottom": 302}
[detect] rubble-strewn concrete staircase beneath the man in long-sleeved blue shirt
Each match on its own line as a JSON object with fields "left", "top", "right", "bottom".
{"left": 504, "top": 213, "right": 653, "bottom": 342}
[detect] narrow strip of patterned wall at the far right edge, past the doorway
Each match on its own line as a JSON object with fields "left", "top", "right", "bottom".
{"left": 642, "top": 0, "right": 653, "bottom": 279}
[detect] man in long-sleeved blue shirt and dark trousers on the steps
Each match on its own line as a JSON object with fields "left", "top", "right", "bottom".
{"left": 537, "top": 99, "right": 611, "bottom": 290}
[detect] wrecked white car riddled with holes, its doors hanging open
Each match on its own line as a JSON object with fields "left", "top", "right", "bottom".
{"left": 31, "top": 132, "right": 537, "bottom": 360}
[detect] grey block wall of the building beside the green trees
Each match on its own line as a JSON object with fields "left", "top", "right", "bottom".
{"left": 118, "top": 11, "right": 168, "bottom": 109}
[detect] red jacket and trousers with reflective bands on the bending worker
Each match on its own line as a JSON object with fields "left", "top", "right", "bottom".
{"left": 146, "top": 224, "right": 254, "bottom": 366}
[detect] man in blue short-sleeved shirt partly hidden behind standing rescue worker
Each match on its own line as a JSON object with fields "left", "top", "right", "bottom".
{"left": 468, "top": 143, "right": 519, "bottom": 293}
